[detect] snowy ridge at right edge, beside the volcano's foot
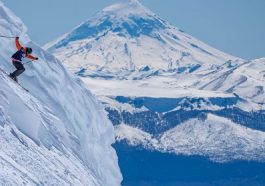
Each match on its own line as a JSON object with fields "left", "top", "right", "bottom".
{"left": 196, "top": 59, "right": 265, "bottom": 103}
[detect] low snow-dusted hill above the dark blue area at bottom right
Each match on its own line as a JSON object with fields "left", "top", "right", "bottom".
{"left": 116, "top": 114, "right": 265, "bottom": 162}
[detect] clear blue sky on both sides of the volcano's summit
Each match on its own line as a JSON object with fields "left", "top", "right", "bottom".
{"left": 2, "top": 0, "right": 265, "bottom": 59}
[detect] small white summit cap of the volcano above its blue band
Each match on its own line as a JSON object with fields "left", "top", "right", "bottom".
{"left": 102, "top": 0, "right": 153, "bottom": 16}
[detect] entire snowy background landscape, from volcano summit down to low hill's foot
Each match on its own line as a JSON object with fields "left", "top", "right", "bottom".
{"left": 45, "top": 0, "right": 265, "bottom": 185}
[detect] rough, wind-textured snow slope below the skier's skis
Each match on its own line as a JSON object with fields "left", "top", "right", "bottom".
{"left": 0, "top": 65, "right": 111, "bottom": 185}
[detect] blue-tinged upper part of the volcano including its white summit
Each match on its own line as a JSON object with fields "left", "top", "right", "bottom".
{"left": 45, "top": 0, "right": 167, "bottom": 50}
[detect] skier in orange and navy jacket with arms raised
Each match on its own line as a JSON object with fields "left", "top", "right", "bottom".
{"left": 9, "top": 37, "right": 38, "bottom": 82}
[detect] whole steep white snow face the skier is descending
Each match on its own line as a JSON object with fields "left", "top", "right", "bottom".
{"left": 0, "top": 2, "right": 122, "bottom": 185}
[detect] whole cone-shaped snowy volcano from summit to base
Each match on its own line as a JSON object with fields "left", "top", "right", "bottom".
{"left": 45, "top": 1, "right": 237, "bottom": 79}
